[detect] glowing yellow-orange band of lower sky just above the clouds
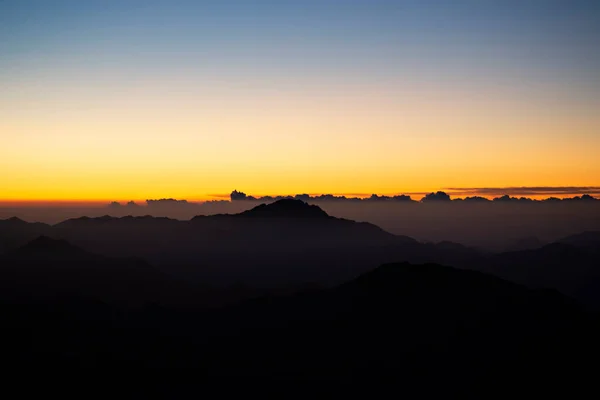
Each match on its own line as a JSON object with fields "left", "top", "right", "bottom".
{"left": 0, "top": 69, "right": 600, "bottom": 202}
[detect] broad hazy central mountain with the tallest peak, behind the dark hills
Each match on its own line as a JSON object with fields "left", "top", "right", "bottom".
{"left": 2, "top": 199, "right": 436, "bottom": 286}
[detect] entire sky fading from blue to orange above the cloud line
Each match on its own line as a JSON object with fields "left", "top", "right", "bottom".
{"left": 0, "top": 0, "right": 600, "bottom": 202}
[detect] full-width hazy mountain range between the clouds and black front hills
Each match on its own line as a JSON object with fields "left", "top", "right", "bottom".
{"left": 0, "top": 199, "right": 600, "bottom": 305}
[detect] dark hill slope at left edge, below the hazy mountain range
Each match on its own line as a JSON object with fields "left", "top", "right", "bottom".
{"left": 0, "top": 236, "right": 195, "bottom": 305}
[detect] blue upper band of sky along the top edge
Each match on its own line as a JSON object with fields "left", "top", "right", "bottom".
{"left": 0, "top": 0, "right": 600, "bottom": 84}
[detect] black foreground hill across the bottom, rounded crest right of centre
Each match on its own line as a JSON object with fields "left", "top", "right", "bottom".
{"left": 0, "top": 248, "right": 597, "bottom": 397}
